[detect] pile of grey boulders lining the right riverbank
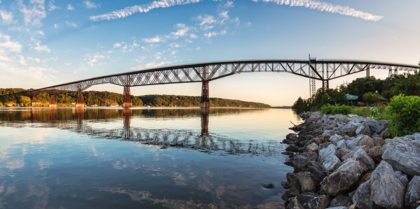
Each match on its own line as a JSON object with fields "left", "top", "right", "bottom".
{"left": 281, "top": 113, "right": 420, "bottom": 209}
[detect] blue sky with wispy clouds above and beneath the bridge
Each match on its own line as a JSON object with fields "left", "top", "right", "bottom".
{"left": 0, "top": 0, "right": 420, "bottom": 106}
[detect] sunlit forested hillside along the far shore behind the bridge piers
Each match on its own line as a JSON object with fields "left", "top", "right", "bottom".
{"left": 0, "top": 88, "right": 270, "bottom": 108}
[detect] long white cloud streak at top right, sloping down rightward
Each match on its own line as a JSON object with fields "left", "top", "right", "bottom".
{"left": 252, "top": 0, "right": 383, "bottom": 21}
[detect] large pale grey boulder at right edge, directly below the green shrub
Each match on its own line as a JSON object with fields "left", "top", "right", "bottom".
{"left": 382, "top": 138, "right": 420, "bottom": 176}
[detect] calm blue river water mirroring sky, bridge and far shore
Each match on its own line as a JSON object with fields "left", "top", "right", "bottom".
{"left": 0, "top": 108, "right": 299, "bottom": 209}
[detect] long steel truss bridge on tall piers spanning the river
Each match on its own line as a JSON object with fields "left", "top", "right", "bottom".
{"left": 0, "top": 58, "right": 419, "bottom": 108}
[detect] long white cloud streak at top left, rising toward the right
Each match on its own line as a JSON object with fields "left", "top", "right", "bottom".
{"left": 90, "top": 0, "right": 201, "bottom": 21}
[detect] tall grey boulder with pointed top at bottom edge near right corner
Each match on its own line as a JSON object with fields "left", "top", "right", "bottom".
{"left": 370, "top": 161, "right": 405, "bottom": 208}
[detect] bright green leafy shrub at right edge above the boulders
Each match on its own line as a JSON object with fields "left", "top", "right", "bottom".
{"left": 388, "top": 94, "right": 420, "bottom": 136}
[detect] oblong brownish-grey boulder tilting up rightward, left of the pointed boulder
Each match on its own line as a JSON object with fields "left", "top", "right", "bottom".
{"left": 321, "top": 158, "right": 368, "bottom": 196}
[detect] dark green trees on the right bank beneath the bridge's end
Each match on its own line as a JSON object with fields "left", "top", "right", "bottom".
{"left": 292, "top": 72, "right": 420, "bottom": 111}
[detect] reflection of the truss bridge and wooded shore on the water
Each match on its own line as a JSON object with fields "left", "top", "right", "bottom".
{"left": 0, "top": 108, "right": 283, "bottom": 156}
